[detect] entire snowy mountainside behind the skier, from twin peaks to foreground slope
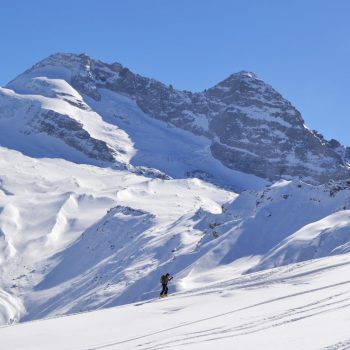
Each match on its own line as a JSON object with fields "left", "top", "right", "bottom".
{"left": 0, "top": 54, "right": 350, "bottom": 330}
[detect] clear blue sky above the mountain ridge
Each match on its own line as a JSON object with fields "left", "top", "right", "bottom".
{"left": 0, "top": 0, "right": 350, "bottom": 145}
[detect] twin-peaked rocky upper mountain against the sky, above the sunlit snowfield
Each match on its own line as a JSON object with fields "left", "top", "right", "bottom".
{"left": 0, "top": 54, "right": 349, "bottom": 183}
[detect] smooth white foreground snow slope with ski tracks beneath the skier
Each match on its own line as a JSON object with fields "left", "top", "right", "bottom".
{"left": 0, "top": 254, "right": 350, "bottom": 350}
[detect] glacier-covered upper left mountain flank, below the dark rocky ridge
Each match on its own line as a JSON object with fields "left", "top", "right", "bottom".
{"left": 0, "top": 61, "right": 266, "bottom": 190}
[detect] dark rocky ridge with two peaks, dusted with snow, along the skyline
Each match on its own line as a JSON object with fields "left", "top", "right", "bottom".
{"left": 8, "top": 54, "right": 350, "bottom": 183}
